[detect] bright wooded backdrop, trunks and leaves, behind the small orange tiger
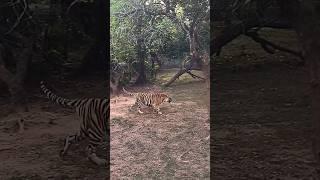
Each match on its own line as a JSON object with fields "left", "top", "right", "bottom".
{"left": 110, "top": 0, "right": 209, "bottom": 86}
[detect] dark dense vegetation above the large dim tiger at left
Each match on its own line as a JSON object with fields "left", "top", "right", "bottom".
{"left": 0, "top": 0, "right": 108, "bottom": 130}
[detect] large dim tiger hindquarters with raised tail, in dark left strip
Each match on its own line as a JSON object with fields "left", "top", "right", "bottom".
{"left": 40, "top": 81, "right": 110, "bottom": 165}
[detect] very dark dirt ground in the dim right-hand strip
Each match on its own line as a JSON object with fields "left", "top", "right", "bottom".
{"left": 211, "top": 30, "right": 315, "bottom": 180}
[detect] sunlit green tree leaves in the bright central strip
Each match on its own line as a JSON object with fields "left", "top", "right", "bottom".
{"left": 110, "top": 0, "right": 210, "bottom": 83}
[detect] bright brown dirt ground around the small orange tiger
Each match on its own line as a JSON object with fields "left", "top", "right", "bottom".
{"left": 111, "top": 70, "right": 210, "bottom": 179}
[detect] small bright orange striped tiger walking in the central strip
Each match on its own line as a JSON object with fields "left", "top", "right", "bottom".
{"left": 123, "top": 88, "right": 172, "bottom": 114}
